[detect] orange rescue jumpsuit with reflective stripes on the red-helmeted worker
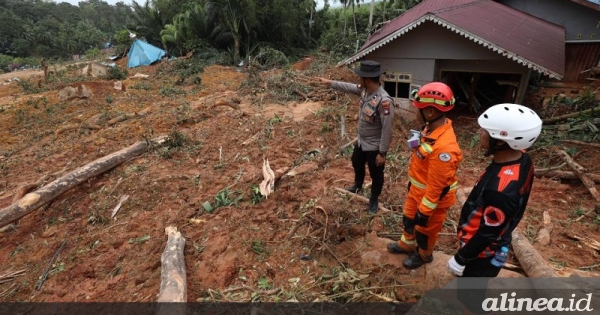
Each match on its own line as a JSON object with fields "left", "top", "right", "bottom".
{"left": 398, "top": 118, "right": 463, "bottom": 258}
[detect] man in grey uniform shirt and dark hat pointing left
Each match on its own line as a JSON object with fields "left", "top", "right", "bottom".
{"left": 317, "top": 60, "right": 394, "bottom": 214}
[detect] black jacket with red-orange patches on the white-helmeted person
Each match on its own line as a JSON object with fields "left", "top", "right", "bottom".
{"left": 455, "top": 153, "right": 534, "bottom": 265}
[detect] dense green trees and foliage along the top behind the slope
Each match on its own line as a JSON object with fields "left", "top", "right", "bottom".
{"left": 0, "top": 0, "right": 419, "bottom": 71}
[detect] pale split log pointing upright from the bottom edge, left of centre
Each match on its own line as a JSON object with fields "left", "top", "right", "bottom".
{"left": 156, "top": 226, "right": 187, "bottom": 315}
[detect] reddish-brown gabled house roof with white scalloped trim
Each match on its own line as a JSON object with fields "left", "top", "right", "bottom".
{"left": 340, "top": 0, "right": 565, "bottom": 79}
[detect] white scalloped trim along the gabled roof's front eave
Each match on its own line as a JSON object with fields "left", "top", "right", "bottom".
{"left": 338, "top": 14, "right": 564, "bottom": 80}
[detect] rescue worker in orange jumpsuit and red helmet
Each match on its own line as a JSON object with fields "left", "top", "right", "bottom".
{"left": 387, "top": 82, "right": 463, "bottom": 269}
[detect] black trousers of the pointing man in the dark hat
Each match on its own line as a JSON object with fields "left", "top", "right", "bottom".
{"left": 352, "top": 144, "right": 385, "bottom": 197}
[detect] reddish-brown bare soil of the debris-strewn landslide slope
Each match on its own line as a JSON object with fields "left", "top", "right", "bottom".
{"left": 0, "top": 60, "right": 600, "bottom": 302}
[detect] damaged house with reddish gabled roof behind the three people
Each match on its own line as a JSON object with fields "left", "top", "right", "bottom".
{"left": 340, "top": 0, "right": 600, "bottom": 118}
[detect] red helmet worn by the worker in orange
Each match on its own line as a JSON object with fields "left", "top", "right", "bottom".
{"left": 412, "top": 82, "right": 454, "bottom": 112}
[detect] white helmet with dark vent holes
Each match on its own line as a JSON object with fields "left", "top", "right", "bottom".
{"left": 477, "top": 103, "right": 542, "bottom": 150}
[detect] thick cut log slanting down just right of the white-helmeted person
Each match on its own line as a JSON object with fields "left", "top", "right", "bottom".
{"left": 511, "top": 229, "right": 558, "bottom": 278}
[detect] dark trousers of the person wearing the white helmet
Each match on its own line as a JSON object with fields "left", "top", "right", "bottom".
{"left": 457, "top": 258, "right": 502, "bottom": 314}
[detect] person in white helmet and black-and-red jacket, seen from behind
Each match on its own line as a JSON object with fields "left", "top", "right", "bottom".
{"left": 447, "top": 104, "right": 542, "bottom": 314}
